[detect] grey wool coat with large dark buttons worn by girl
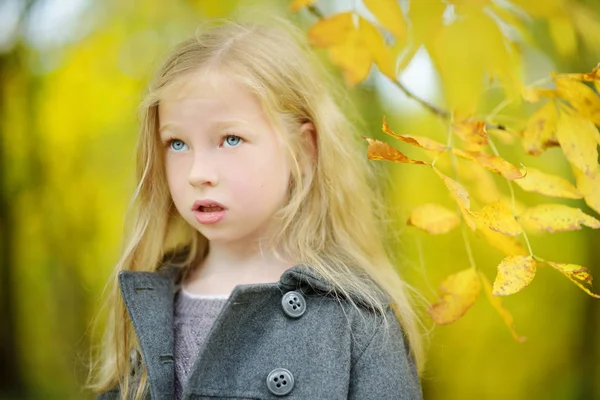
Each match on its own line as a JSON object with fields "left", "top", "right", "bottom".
{"left": 99, "top": 265, "right": 422, "bottom": 400}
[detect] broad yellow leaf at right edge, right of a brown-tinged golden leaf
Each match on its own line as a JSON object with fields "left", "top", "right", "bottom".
{"left": 556, "top": 112, "right": 599, "bottom": 176}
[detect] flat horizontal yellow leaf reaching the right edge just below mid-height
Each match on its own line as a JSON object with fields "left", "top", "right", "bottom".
{"left": 519, "top": 204, "right": 600, "bottom": 232}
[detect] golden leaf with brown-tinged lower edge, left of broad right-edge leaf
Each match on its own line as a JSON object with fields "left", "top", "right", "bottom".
{"left": 523, "top": 102, "right": 558, "bottom": 156}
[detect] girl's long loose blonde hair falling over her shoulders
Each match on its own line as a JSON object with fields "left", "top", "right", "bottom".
{"left": 89, "top": 17, "right": 425, "bottom": 398}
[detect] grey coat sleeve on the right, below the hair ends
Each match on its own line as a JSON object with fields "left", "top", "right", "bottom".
{"left": 348, "top": 307, "right": 423, "bottom": 400}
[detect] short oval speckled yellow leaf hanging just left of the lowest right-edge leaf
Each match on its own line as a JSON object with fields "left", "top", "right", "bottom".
{"left": 492, "top": 256, "right": 536, "bottom": 296}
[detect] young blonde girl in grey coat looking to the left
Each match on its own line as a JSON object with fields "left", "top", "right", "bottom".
{"left": 91, "top": 16, "right": 424, "bottom": 400}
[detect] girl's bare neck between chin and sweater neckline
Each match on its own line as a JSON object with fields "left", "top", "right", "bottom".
{"left": 183, "top": 243, "right": 295, "bottom": 295}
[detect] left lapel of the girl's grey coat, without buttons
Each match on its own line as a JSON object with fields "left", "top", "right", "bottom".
{"left": 119, "top": 271, "right": 176, "bottom": 400}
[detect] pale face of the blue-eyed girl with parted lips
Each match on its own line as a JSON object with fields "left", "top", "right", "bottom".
{"left": 159, "top": 74, "right": 290, "bottom": 245}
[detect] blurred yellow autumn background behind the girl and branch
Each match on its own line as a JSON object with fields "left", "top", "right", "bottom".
{"left": 0, "top": 0, "right": 600, "bottom": 400}
